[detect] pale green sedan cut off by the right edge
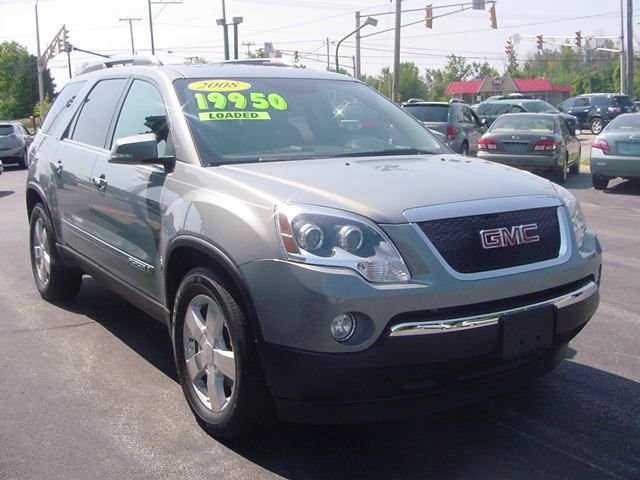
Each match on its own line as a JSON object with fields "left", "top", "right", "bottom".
{"left": 590, "top": 113, "right": 640, "bottom": 190}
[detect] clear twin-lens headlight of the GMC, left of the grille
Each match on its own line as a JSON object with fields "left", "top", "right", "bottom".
{"left": 276, "top": 205, "right": 411, "bottom": 283}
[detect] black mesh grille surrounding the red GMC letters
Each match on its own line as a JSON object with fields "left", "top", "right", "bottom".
{"left": 418, "top": 207, "right": 560, "bottom": 273}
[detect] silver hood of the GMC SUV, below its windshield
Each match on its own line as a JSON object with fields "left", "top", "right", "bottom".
{"left": 210, "top": 155, "right": 557, "bottom": 223}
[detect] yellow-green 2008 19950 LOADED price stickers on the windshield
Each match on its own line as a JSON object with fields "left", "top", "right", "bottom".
{"left": 188, "top": 80, "right": 288, "bottom": 121}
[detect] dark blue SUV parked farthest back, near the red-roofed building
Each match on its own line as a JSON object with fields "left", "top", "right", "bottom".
{"left": 558, "top": 93, "right": 636, "bottom": 135}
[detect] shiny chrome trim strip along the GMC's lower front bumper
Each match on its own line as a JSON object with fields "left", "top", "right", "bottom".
{"left": 389, "top": 282, "right": 598, "bottom": 337}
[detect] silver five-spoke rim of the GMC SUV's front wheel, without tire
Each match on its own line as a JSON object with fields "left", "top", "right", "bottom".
{"left": 182, "top": 295, "right": 236, "bottom": 413}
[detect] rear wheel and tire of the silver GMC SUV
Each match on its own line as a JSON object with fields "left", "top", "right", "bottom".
{"left": 29, "top": 203, "right": 82, "bottom": 302}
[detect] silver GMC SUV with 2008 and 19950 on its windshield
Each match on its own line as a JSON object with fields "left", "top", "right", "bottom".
{"left": 26, "top": 58, "right": 601, "bottom": 438}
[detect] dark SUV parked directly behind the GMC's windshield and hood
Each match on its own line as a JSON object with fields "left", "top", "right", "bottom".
{"left": 402, "top": 102, "right": 486, "bottom": 155}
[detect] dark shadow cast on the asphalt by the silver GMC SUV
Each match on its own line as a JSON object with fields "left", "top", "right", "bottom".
{"left": 64, "top": 277, "right": 640, "bottom": 480}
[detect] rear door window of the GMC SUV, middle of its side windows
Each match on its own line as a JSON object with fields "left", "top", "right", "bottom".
{"left": 71, "top": 78, "right": 127, "bottom": 148}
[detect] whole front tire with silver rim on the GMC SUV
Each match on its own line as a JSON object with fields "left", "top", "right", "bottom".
{"left": 172, "top": 268, "right": 276, "bottom": 439}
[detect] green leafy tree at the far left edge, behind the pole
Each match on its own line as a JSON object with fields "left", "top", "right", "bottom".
{"left": 0, "top": 42, "right": 55, "bottom": 119}
